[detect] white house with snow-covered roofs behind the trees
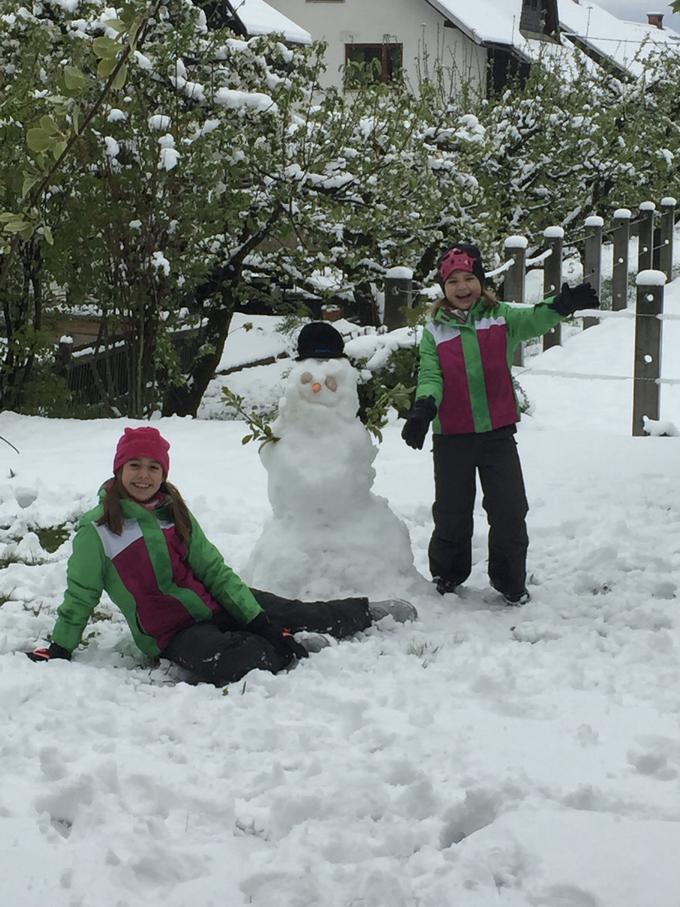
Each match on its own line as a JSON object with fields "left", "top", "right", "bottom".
{"left": 251, "top": 0, "right": 680, "bottom": 93}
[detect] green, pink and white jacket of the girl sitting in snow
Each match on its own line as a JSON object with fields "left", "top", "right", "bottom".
{"left": 52, "top": 493, "right": 262, "bottom": 656}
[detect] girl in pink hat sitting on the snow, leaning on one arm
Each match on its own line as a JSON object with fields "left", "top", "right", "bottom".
{"left": 28, "top": 427, "right": 416, "bottom": 686}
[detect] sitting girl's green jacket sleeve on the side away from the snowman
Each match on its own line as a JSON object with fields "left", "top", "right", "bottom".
{"left": 52, "top": 525, "right": 106, "bottom": 652}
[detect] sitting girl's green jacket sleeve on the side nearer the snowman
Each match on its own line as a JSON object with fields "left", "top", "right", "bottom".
{"left": 187, "top": 516, "right": 262, "bottom": 624}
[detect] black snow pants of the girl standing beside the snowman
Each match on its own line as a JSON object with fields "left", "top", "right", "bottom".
{"left": 428, "top": 426, "right": 529, "bottom": 594}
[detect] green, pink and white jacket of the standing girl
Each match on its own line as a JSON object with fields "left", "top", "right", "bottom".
{"left": 416, "top": 298, "right": 562, "bottom": 435}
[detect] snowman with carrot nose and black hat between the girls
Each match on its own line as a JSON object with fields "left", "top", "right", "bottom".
{"left": 244, "top": 322, "right": 423, "bottom": 599}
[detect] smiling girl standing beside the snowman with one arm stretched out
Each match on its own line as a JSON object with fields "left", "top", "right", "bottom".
{"left": 402, "top": 243, "right": 600, "bottom": 605}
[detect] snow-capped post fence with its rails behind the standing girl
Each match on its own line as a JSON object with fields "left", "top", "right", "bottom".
{"left": 384, "top": 196, "right": 680, "bottom": 436}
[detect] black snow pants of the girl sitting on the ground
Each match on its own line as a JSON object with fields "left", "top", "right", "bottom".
{"left": 161, "top": 589, "right": 371, "bottom": 686}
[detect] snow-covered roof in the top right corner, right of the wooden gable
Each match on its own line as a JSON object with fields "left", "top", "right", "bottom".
{"left": 558, "top": 0, "right": 680, "bottom": 76}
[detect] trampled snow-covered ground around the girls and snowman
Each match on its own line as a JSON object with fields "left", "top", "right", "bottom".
{"left": 0, "top": 281, "right": 680, "bottom": 907}
